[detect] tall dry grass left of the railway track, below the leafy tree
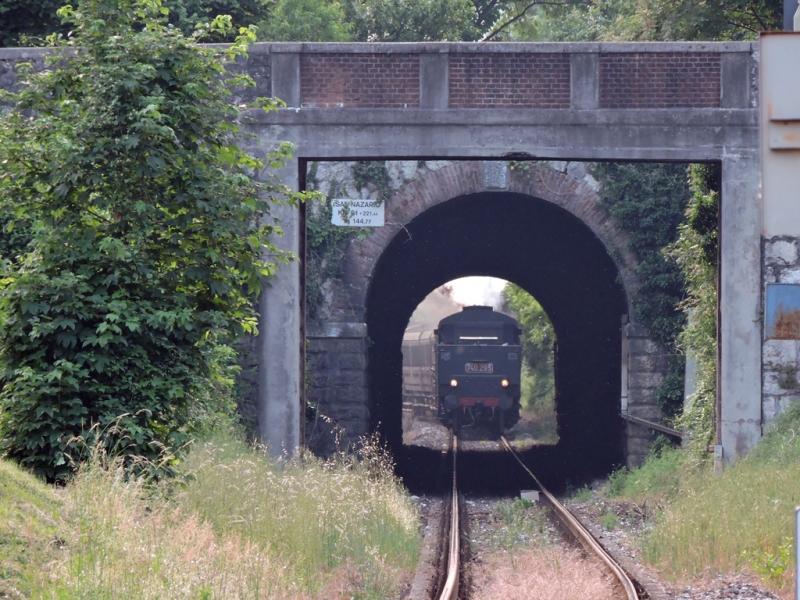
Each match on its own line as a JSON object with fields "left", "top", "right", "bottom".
{"left": 12, "top": 438, "right": 418, "bottom": 600}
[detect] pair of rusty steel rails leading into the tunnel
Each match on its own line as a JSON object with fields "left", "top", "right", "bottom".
{"left": 435, "top": 435, "right": 640, "bottom": 600}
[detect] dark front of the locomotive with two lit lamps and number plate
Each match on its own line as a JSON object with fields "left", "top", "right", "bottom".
{"left": 436, "top": 306, "right": 522, "bottom": 433}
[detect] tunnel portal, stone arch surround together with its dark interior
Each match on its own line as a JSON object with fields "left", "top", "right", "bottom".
{"left": 307, "top": 161, "right": 666, "bottom": 475}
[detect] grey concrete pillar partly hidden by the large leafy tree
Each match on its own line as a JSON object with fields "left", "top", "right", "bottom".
{"left": 257, "top": 160, "right": 304, "bottom": 456}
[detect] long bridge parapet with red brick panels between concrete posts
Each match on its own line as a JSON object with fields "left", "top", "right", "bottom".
{"left": 0, "top": 42, "right": 757, "bottom": 110}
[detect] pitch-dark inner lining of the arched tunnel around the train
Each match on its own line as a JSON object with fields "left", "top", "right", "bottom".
{"left": 367, "top": 192, "right": 627, "bottom": 491}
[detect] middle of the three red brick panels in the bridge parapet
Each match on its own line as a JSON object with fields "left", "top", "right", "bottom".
{"left": 450, "top": 53, "right": 570, "bottom": 108}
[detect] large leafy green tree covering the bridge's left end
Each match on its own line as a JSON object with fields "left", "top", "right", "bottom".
{"left": 0, "top": 0, "right": 310, "bottom": 479}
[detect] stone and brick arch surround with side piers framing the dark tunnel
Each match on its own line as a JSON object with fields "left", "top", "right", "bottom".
{"left": 308, "top": 161, "right": 666, "bottom": 474}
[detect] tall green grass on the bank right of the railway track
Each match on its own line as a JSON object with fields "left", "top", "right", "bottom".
{"left": 611, "top": 403, "right": 800, "bottom": 589}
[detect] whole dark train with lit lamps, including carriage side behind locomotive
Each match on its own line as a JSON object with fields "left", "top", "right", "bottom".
{"left": 403, "top": 306, "right": 522, "bottom": 434}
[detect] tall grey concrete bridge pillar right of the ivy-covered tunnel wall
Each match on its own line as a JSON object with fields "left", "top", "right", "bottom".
{"left": 717, "top": 152, "right": 761, "bottom": 462}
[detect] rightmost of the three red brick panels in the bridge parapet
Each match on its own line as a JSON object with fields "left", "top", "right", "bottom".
{"left": 600, "top": 52, "right": 720, "bottom": 108}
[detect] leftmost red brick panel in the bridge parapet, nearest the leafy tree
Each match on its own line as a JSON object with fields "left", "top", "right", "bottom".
{"left": 300, "top": 54, "right": 419, "bottom": 108}
